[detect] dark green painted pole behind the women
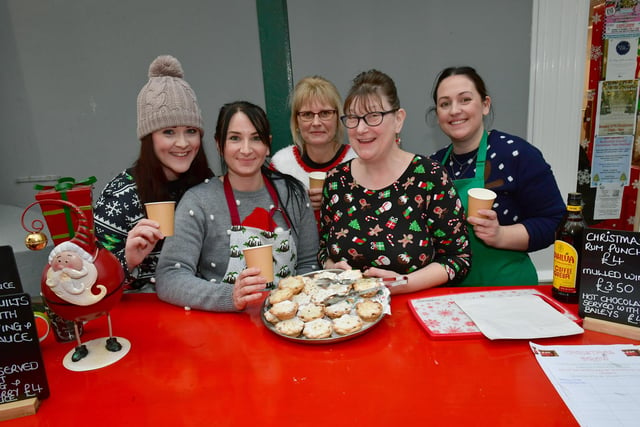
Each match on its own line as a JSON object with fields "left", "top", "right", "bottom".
{"left": 256, "top": 0, "right": 293, "bottom": 154}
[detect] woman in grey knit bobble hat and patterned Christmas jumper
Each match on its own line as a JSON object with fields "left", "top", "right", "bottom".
{"left": 94, "top": 55, "right": 213, "bottom": 291}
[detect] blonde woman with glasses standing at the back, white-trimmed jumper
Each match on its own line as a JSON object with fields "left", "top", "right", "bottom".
{"left": 271, "top": 76, "right": 356, "bottom": 216}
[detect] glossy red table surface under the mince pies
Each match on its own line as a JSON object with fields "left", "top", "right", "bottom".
{"left": 2, "top": 286, "right": 638, "bottom": 427}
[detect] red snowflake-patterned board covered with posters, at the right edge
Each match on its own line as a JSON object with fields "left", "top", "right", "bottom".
{"left": 577, "top": 0, "right": 640, "bottom": 231}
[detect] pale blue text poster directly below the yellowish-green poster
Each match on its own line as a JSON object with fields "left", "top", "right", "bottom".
{"left": 591, "top": 135, "right": 634, "bottom": 188}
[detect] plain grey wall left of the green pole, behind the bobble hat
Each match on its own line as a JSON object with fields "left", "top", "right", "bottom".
{"left": 0, "top": 0, "right": 264, "bottom": 206}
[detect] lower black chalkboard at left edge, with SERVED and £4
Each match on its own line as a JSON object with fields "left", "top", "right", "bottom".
{"left": 0, "top": 293, "right": 49, "bottom": 409}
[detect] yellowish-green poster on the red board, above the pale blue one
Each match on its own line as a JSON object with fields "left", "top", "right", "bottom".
{"left": 596, "top": 80, "right": 638, "bottom": 137}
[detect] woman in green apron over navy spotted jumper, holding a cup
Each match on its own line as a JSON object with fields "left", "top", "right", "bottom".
{"left": 431, "top": 67, "right": 565, "bottom": 286}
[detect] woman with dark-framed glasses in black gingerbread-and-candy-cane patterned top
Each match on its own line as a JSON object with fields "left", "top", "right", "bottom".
{"left": 318, "top": 70, "right": 471, "bottom": 294}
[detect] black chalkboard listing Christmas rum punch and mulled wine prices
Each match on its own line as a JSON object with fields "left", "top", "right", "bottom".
{"left": 579, "top": 228, "right": 640, "bottom": 327}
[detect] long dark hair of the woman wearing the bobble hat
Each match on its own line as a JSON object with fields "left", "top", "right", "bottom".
{"left": 132, "top": 134, "right": 213, "bottom": 203}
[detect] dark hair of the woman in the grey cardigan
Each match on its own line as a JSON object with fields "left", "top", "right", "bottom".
{"left": 215, "top": 101, "right": 306, "bottom": 231}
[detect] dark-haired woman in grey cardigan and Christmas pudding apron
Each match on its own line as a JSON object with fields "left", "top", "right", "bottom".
{"left": 156, "top": 101, "right": 318, "bottom": 311}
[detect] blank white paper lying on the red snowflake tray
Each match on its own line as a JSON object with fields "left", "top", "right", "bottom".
{"left": 454, "top": 295, "right": 584, "bottom": 340}
